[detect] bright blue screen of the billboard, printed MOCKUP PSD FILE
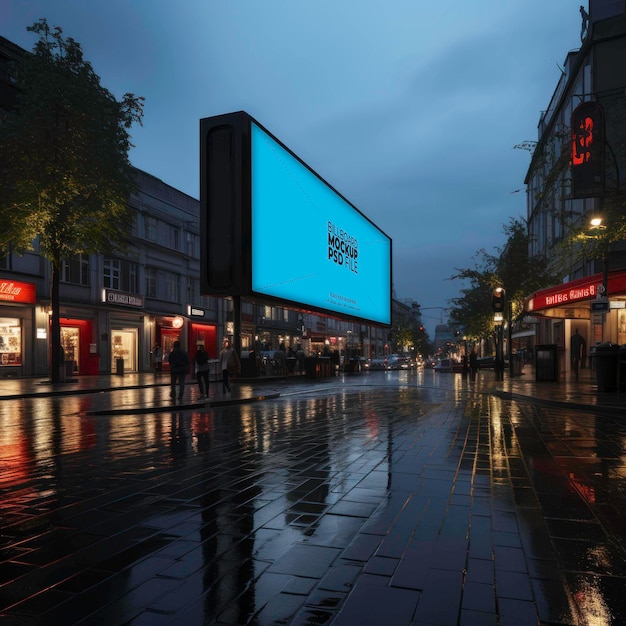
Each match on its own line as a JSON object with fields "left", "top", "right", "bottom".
{"left": 250, "top": 121, "right": 391, "bottom": 325}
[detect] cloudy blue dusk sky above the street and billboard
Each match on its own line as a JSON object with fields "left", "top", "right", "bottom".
{"left": 0, "top": 0, "right": 587, "bottom": 337}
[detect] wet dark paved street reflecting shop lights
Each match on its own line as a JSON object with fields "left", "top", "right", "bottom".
{"left": 0, "top": 370, "right": 626, "bottom": 626}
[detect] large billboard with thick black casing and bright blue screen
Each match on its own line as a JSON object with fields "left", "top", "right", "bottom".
{"left": 200, "top": 112, "right": 391, "bottom": 325}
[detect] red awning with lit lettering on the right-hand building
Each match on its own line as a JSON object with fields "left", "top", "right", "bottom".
{"left": 524, "top": 271, "right": 626, "bottom": 317}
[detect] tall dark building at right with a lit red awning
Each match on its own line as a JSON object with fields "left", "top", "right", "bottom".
{"left": 525, "top": 0, "right": 626, "bottom": 371}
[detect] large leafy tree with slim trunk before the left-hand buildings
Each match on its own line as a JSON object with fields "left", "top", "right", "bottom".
{"left": 0, "top": 19, "right": 143, "bottom": 382}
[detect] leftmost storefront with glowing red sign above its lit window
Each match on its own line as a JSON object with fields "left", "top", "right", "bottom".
{"left": 0, "top": 278, "right": 37, "bottom": 377}
